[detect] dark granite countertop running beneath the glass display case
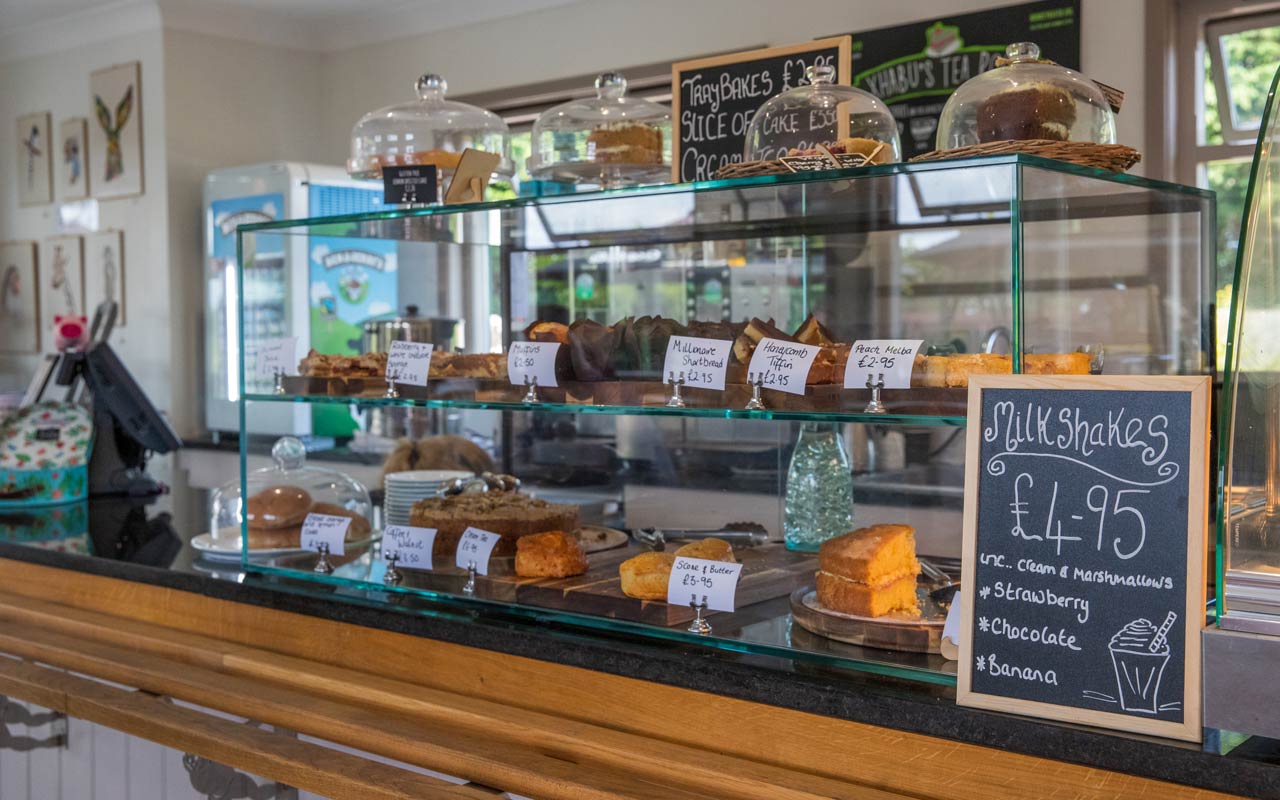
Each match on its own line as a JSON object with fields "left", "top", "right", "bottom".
{"left": 0, "top": 500, "right": 1280, "bottom": 797}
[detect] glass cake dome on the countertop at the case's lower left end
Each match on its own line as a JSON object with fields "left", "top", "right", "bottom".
{"left": 210, "top": 436, "right": 372, "bottom": 549}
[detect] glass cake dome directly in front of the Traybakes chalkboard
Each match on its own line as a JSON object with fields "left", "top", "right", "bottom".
{"left": 742, "top": 64, "right": 902, "bottom": 164}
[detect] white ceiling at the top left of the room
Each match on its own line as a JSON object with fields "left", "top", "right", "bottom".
{"left": 0, "top": 0, "right": 579, "bottom": 51}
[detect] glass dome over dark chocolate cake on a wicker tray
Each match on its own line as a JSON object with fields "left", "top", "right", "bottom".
{"left": 937, "top": 42, "right": 1116, "bottom": 150}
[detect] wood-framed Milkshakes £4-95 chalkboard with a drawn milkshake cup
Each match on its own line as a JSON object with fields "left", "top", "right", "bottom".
{"left": 957, "top": 375, "right": 1210, "bottom": 741}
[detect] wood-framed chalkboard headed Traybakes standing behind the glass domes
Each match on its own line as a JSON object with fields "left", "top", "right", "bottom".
{"left": 671, "top": 36, "right": 849, "bottom": 183}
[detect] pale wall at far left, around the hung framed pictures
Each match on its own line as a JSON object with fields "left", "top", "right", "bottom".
{"left": 0, "top": 27, "right": 173, "bottom": 411}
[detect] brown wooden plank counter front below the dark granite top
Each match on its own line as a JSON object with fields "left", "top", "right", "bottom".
{"left": 0, "top": 559, "right": 1228, "bottom": 800}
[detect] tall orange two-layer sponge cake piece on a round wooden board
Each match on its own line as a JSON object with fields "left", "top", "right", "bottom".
{"left": 817, "top": 525, "right": 920, "bottom": 617}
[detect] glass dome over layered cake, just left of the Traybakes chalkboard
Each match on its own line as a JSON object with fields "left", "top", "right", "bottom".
{"left": 529, "top": 72, "right": 671, "bottom": 188}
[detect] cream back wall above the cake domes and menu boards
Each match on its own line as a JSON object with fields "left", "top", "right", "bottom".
{"left": 323, "top": 0, "right": 1146, "bottom": 164}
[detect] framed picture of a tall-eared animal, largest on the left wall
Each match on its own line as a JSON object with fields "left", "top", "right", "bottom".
{"left": 88, "top": 61, "right": 142, "bottom": 200}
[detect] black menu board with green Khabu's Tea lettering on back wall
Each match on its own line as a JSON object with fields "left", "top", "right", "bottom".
{"left": 851, "top": 0, "right": 1080, "bottom": 161}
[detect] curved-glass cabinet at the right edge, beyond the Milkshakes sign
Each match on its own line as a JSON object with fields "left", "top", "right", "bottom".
{"left": 1217, "top": 68, "right": 1280, "bottom": 635}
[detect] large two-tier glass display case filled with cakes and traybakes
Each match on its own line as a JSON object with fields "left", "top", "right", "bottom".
{"left": 238, "top": 155, "right": 1215, "bottom": 684}
